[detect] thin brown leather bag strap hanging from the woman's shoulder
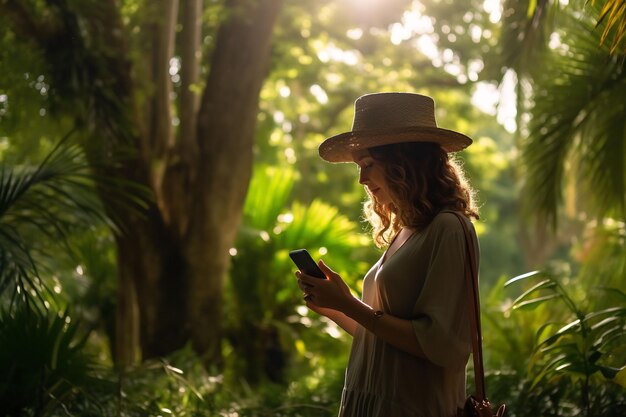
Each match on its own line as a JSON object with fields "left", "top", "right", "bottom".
{"left": 450, "top": 211, "right": 487, "bottom": 400}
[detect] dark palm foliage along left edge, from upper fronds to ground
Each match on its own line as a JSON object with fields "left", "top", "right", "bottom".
{"left": 0, "top": 138, "right": 143, "bottom": 416}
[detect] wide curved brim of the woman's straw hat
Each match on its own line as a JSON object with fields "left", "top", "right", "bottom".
{"left": 319, "top": 127, "right": 472, "bottom": 162}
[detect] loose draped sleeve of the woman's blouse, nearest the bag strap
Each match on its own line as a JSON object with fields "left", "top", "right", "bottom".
{"left": 412, "top": 214, "right": 473, "bottom": 367}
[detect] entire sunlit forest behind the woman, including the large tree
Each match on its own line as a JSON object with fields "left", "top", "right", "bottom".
{"left": 0, "top": 0, "right": 626, "bottom": 417}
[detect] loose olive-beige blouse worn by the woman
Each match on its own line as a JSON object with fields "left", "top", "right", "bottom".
{"left": 339, "top": 211, "right": 478, "bottom": 417}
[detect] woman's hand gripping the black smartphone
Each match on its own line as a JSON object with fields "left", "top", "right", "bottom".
{"left": 296, "top": 261, "right": 354, "bottom": 311}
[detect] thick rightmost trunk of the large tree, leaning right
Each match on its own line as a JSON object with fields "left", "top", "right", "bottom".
{"left": 185, "top": 0, "right": 281, "bottom": 362}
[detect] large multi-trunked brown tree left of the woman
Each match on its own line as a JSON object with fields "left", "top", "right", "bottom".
{"left": 0, "top": 0, "right": 281, "bottom": 365}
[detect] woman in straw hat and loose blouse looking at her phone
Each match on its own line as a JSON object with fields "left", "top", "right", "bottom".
{"left": 296, "top": 93, "right": 478, "bottom": 417}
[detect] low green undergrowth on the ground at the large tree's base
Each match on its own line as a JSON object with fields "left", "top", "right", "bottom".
{"left": 43, "top": 346, "right": 344, "bottom": 417}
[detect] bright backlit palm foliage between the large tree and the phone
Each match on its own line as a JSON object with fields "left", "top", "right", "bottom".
{"left": 226, "top": 166, "right": 367, "bottom": 384}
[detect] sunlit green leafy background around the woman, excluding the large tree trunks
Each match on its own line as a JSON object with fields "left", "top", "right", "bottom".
{"left": 0, "top": 0, "right": 626, "bottom": 416}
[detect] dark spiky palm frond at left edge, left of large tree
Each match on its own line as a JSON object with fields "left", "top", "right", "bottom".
{"left": 0, "top": 138, "right": 123, "bottom": 305}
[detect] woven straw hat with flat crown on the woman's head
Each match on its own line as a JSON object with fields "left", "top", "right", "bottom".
{"left": 319, "top": 93, "right": 472, "bottom": 162}
